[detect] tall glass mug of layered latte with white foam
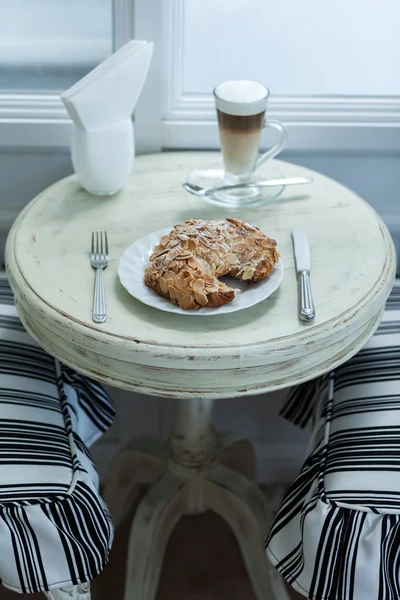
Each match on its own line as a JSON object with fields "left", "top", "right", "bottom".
{"left": 214, "top": 80, "right": 287, "bottom": 204}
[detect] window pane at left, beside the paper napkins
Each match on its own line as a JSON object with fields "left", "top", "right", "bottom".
{"left": 0, "top": 0, "right": 113, "bottom": 92}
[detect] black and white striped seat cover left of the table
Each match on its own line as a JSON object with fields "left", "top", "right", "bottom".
{"left": 0, "top": 276, "right": 114, "bottom": 593}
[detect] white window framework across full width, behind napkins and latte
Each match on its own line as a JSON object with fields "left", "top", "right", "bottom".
{"left": 0, "top": 0, "right": 400, "bottom": 154}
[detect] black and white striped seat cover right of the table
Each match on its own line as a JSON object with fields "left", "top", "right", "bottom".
{"left": 266, "top": 280, "right": 400, "bottom": 600}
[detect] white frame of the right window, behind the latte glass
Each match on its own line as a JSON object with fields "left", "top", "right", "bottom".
{"left": 157, "top": 0, "right": 400, "bottom": 153}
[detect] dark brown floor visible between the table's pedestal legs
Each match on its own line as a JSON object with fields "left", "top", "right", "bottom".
{"left": 0, "top": 442, "right": 303, "bottom": 600}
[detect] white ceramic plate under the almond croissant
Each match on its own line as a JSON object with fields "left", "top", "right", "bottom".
{"left": 118, "top": 228, "right": 283, "bottom": 317}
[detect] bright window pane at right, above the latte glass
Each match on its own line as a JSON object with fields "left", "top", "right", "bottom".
{"left": 183, "top": 0, "right": 400, "bottom": 96}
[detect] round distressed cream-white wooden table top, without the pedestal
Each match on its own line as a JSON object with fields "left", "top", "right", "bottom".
{"left": 7, "top": 152, "right": 395, "bottom": 397}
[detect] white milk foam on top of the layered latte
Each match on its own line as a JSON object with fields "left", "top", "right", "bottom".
{"left": 214, "top": 79, "right": 269, "bottom": 116}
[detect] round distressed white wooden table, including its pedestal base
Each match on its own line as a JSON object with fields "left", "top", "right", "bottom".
{"left": 6, "top": 152, "right": 395, "bottom": 600}
